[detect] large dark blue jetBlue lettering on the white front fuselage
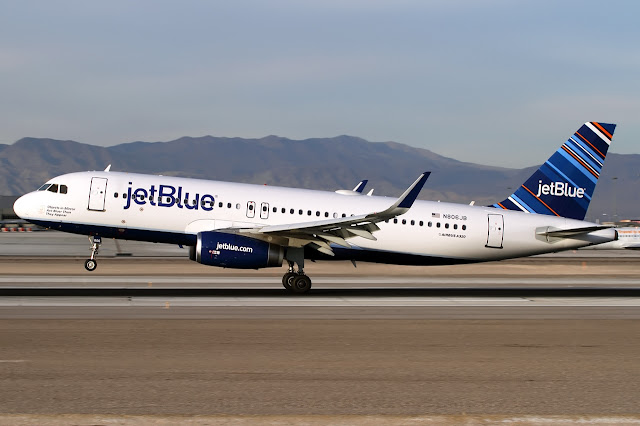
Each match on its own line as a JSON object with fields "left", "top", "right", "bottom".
{"left": 124, "top": 182, "right": 215, "bottom": 211}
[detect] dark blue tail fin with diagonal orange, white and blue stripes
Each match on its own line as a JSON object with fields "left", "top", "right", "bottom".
{"left": 491, "top": 121, "right": 616, "bottom": 220}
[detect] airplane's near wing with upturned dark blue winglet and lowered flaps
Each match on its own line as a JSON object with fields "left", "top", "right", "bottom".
{"left": 228, "top": 172, "right": 431, "bottom": 256}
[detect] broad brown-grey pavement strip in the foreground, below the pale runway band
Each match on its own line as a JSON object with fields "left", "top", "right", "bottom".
{"left": 0, "top": 319, "right": 640, "bottom": 416}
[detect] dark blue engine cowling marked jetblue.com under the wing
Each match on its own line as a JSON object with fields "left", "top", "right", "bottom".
{"left": 189, "top": 231, "right": 284, "bottom": 269}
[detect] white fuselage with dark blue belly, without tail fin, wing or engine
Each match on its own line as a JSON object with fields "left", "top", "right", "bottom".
{"left": 14, "top": 172, "right": 616, "bottom": 265}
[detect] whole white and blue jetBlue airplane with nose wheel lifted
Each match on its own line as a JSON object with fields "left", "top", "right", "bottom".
{"left": 14, "top": 122, "right": 617, "bottom": 293}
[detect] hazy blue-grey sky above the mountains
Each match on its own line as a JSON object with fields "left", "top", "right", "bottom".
{"left": 0, "top": 0, "right": 640, "bottom": 167}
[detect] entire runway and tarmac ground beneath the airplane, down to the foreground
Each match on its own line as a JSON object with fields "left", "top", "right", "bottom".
{"left": 0, "top": 233, "right": 640, "bottom": 425}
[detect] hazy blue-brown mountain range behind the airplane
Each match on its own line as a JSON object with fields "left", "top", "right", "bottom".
{"left": 0, "top": 136, "right": 640, "bottom": 221}
